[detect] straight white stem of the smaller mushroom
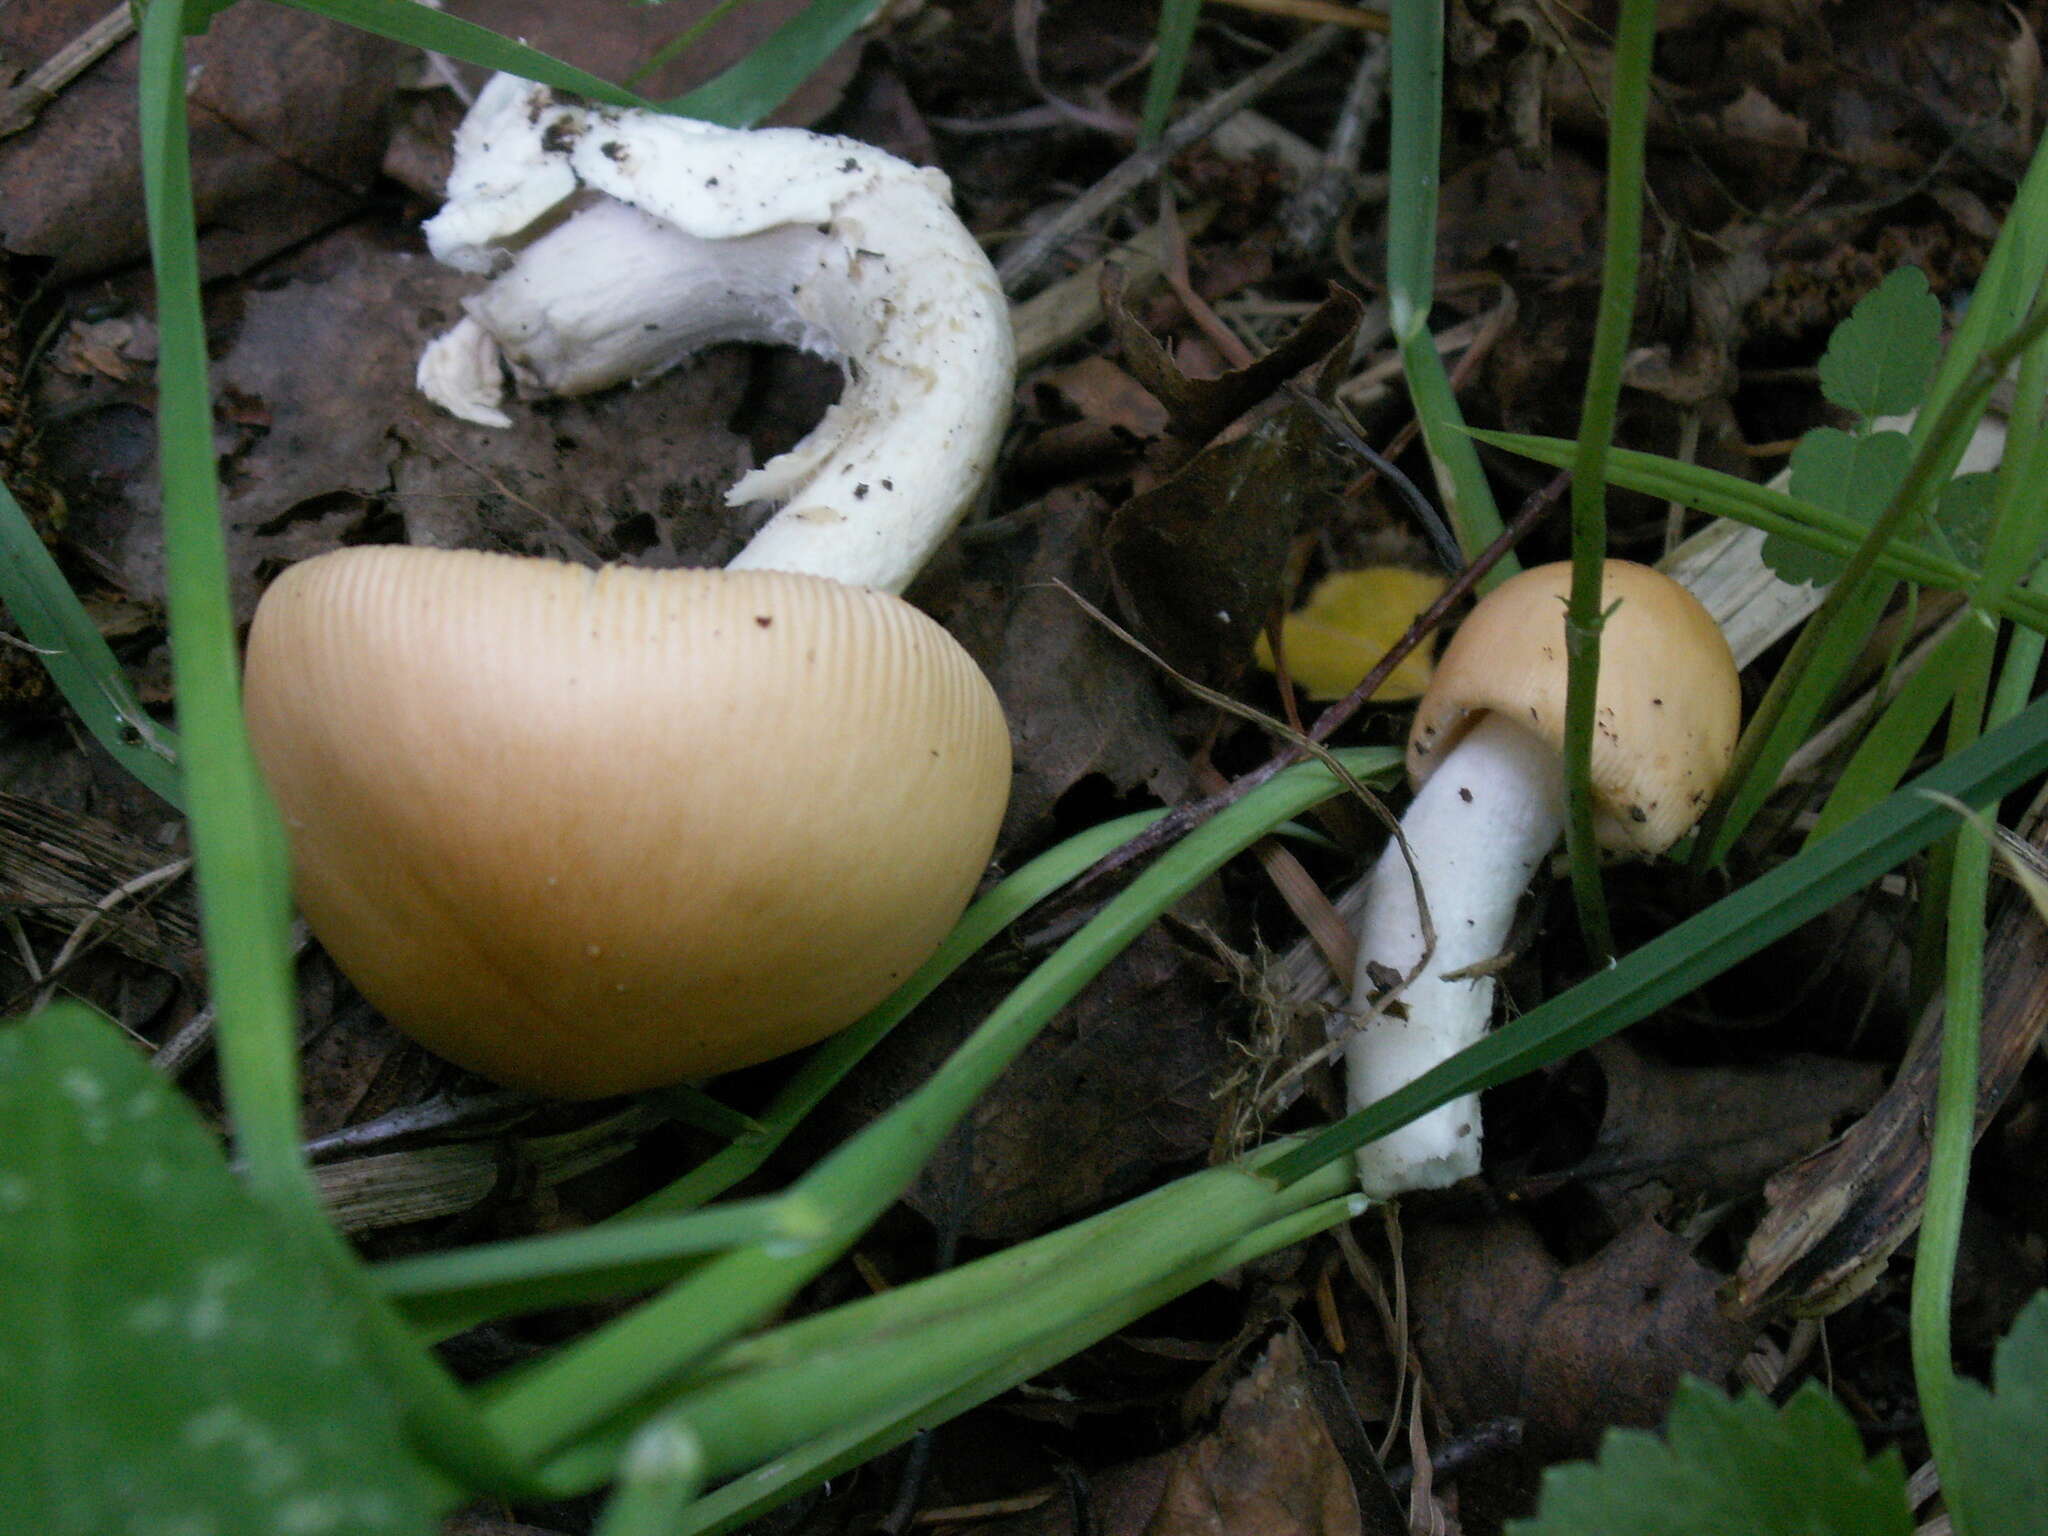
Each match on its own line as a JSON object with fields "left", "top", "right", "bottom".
{"left": 1346, "top": 715, "right": 1565, "bottom": 1200}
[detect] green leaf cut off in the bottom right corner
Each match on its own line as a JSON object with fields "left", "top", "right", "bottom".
{"left": 1944, "top": 1290, "right": 2048, "bottom": 1536}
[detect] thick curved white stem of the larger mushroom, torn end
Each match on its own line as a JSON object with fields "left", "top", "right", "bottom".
{"left": 418, "top": 76, "right": 1014, "bottom": 592}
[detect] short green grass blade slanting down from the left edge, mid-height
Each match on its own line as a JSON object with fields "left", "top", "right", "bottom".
{"left": 0, "top": 485, "right": 184, "bottom": 809}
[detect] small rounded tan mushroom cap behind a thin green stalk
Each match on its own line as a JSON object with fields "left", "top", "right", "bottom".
{"left": 1407, "top": 559, "right": 1743, "bottom": 854}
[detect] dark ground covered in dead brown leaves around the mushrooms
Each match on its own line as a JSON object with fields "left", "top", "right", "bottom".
{"left": 0, "top": 0, "right": 2048, "bottom": 1536}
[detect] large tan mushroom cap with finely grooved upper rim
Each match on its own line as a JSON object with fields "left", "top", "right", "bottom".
{"left": 246, "top": 549, "right": 1010, "bottom": 1098}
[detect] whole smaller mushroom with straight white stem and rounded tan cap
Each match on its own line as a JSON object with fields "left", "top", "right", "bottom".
{"left": 1346, "top": 559, "right": 1741, "bottom": 1198}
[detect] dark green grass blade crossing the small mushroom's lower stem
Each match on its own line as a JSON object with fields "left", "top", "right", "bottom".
{"left": 1272, "top": 698, "right": 2048, "bottom": 1178}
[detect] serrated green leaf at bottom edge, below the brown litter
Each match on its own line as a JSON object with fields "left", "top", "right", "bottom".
{"left": 1507, "top": 1380, "right": 1913, "bottom": 1536}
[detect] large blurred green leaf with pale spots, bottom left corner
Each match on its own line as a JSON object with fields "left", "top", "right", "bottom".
{"left": 0, "top": 1006, "right": 434, "bottom": 1536}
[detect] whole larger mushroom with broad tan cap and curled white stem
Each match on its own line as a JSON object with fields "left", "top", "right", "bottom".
{"left": 244, "top": 76, "right": 1012, "bottom": 1098}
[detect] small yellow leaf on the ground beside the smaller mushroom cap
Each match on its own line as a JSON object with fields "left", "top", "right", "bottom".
{"left": 1253, "top": 565, "right": 1444, "bottom": 705}
